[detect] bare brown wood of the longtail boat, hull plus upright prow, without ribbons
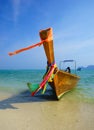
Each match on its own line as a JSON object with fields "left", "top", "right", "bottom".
{"left": 40, "top": 28, "right": 79, "bottom": 99}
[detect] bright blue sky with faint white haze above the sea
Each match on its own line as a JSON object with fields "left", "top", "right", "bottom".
{"left": 0, "top": 0, "right": 94, "bottom": 69}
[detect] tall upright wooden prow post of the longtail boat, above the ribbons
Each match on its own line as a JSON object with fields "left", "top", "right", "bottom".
{"left": 39, "top": 28, "right": 55, "bottom": 64}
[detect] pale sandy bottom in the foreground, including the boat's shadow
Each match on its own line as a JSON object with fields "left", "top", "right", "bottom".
{"left": 0, "top": 92, "right": 94, "bottom": 130}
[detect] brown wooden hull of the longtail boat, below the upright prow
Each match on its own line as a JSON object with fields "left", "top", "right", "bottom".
{"left": 49, "top": 70, "right": 79, "bottom": 99}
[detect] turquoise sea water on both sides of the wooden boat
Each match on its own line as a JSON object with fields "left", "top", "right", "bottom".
{"left": 0, "top": 70, "right": 94, "bottom": 101}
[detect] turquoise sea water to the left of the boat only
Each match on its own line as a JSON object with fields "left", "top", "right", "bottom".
{"left": 0, "top": 70, "right": 44, "bottom": 92}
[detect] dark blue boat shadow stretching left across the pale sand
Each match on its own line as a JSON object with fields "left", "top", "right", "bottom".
{"left": 0, "top": 90, "right": 56, "bottom": 109}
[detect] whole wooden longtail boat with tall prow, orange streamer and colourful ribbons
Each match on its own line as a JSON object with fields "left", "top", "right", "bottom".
{"left": 9, "top": 28, "right": 79, "bottom": 99}
